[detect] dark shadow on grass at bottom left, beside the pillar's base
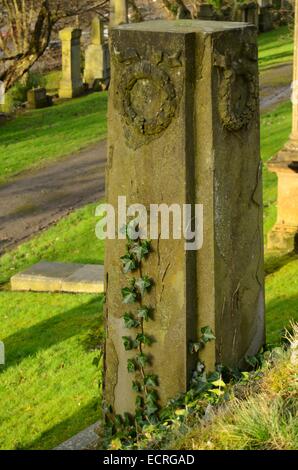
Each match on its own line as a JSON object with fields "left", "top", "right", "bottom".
{"left": 14, "top": 397, "right": 101, "bottom": 450}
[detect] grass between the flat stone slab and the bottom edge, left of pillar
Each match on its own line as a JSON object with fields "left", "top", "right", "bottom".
{"left": 0, "top": 292, "right": 102, "bottom": 449}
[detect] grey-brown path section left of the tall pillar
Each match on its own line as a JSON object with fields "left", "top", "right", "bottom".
{"left": 0, "top": 141, "right": 106, "bottom": 254}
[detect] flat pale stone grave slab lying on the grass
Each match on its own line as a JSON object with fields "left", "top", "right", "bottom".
{"left": 11, "top": 261, "right": 104, "bottom": 294}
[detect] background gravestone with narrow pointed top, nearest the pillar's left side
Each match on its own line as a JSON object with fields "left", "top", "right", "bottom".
{"left": 84, "top": 17, "right": 110, "bottom": 88}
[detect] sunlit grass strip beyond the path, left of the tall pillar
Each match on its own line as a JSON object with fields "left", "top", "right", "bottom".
{"left": 0, "top": 92, "right": 107, "bottom": 184}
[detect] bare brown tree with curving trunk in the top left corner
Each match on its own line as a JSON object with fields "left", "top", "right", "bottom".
{"left": 0, "top": 0, "right": 109, "bottom": 90}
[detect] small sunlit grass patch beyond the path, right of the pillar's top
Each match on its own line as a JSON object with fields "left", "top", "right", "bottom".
{"left": 259, "top": 26, "right": 294, "bottom": 71}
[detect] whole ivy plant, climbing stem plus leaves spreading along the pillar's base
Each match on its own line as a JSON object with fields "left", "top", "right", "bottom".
{"left": 103, "top": 221, "right": 219, "bottom": 449}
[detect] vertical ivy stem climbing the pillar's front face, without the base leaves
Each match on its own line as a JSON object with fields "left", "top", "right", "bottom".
{"left": 121, "top": 224, "right": 159, "bottom": 429}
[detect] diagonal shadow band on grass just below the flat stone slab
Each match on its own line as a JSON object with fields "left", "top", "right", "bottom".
{"left": 0, "top": 296, "right": 103, "bottom": 373}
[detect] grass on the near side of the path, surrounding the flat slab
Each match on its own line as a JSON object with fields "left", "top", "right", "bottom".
{"left": 0, "top": 205, "right": 103, "bottom": 449}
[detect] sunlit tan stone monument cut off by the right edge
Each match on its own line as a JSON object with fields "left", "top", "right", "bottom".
{"left": 267, "top": 1, "right": 298, "bottom": 251}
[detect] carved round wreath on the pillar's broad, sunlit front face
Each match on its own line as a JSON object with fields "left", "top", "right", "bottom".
{"left": 114, "top": 49, "right": 181, "bottom": 148}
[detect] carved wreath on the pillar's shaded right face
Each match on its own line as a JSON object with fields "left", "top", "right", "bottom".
{"left": 214, "top": 44, "right": 258, "bottom": 131}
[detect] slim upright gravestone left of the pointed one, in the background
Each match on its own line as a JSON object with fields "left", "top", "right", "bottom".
{"left": 59, "top": 28, "right": 83, "bottom": 98}
